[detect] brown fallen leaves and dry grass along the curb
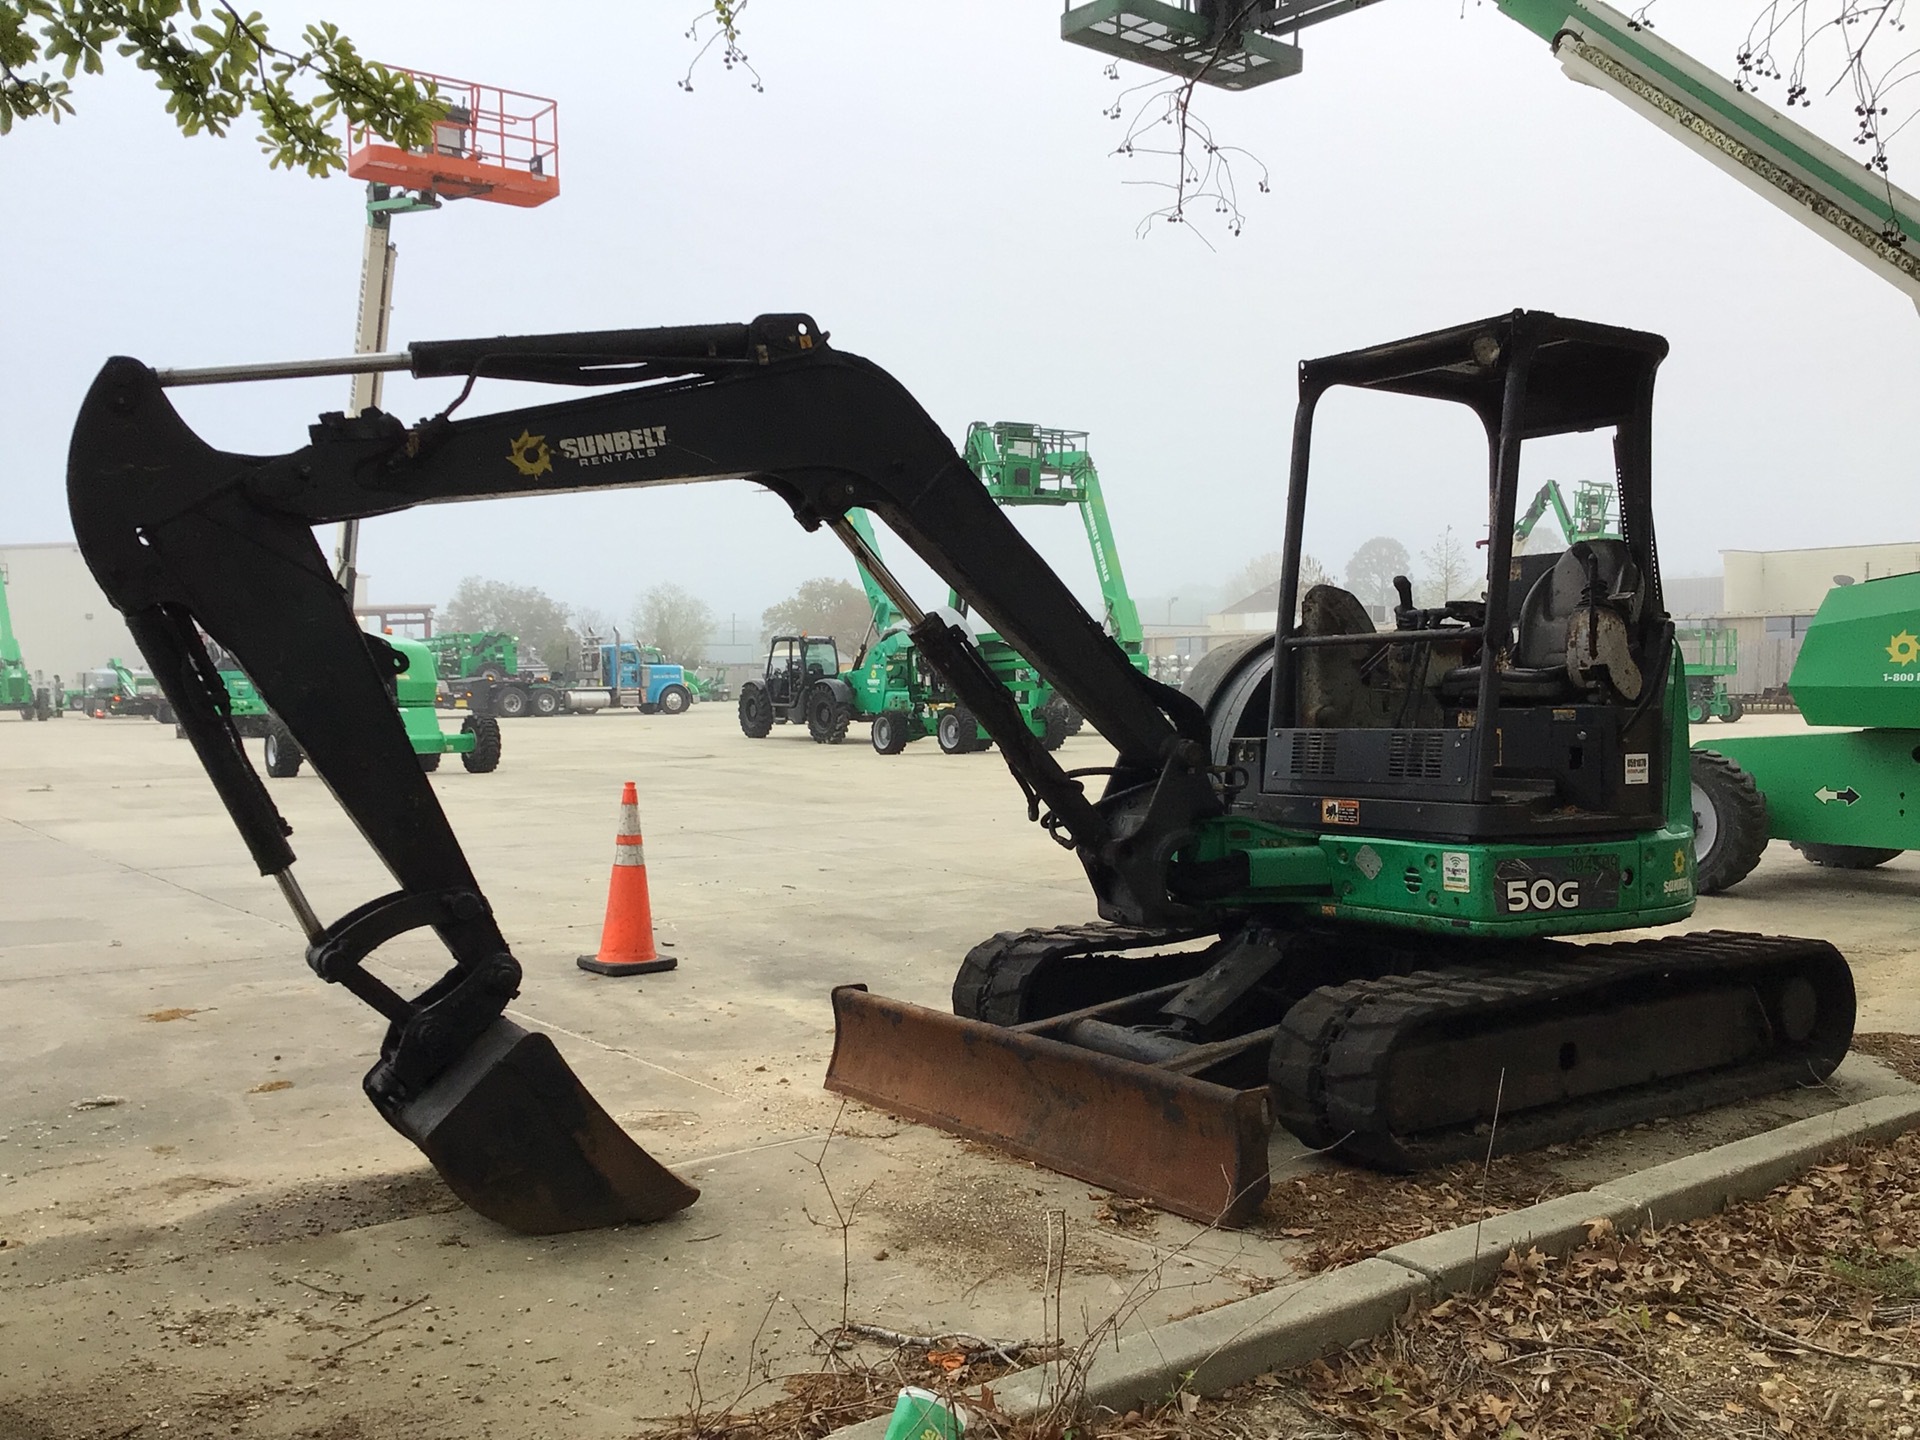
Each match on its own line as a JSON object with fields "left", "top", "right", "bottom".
{"left": 622, "top": 1135, "right": 1920, "bottom": 1440}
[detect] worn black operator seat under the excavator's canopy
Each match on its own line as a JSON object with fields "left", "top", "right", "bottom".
{"left": 1440, "top": 540, "right": 1645, "bottom": 703}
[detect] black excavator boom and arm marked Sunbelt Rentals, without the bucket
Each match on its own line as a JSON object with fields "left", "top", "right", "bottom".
{"left": 69, "top": 317, "right": 1215, "bottom": 990}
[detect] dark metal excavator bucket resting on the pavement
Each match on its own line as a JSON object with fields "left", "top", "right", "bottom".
{"left": 382, "top": 1020, "right": 701, "bottom": 1235}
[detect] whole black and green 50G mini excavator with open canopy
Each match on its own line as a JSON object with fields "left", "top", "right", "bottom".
{"left": 69, "top": 311, "right": 1853, "bottom": 1233}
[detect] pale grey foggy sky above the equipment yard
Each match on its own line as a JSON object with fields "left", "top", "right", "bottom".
{"left": 0, "top": 0, "right": 1920, "bottom": 636}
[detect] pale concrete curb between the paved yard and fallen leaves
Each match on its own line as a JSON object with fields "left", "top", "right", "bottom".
{"left": 828, "top": 1091, "right": 1920, "bottom": 1440}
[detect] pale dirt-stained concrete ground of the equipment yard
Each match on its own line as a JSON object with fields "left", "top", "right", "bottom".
{"left": 0, "top": 707, "right": 1920, "bottom": 1440}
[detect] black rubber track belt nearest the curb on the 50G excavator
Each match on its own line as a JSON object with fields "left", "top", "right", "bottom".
{"left": 1271, "top": 931, "right": 1853, "bottom": 1171}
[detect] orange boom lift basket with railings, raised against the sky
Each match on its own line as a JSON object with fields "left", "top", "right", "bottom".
{"left": 348, "top": 65, "right": 561, "bottom": 207}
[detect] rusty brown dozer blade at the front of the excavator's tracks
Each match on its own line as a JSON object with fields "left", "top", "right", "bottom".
{"left": 828, "top": 985, "right": 1273, "bottom": 1225}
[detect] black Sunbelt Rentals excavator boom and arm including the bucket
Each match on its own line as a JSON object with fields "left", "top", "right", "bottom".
{"left": 67, "top": 315, "right": 1219, "bottom": 1231}
